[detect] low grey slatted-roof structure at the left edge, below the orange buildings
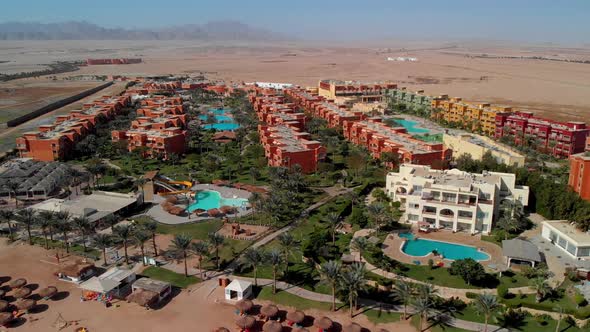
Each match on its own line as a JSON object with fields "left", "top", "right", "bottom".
{"left": 0, "top": 158, "right": 71, "bottom": 201}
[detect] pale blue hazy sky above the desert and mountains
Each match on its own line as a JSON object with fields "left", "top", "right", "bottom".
{"left": 0, "top": 0, "right": 590, "bottom": 43}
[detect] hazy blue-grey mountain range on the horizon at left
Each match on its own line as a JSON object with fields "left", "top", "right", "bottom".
{"left": 0, "top": 21, "right": 292, "bottom": 41}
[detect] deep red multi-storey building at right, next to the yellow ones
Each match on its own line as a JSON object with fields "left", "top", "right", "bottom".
{"left": 494, "top": 112, "right": 590, "bottom": 157}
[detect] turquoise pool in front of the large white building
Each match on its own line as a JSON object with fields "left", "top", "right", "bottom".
{"left": 399, "top": 233, "right": 490, "bottom": 261}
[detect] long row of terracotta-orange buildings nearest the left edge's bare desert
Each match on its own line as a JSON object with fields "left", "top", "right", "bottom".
{"left": 16, "top": 96, "right": 131, "bottom": 161}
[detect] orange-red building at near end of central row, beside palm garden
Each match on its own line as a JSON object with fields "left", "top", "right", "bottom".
{"left": 258, "top": 125, "right": 326, "bottom": 173}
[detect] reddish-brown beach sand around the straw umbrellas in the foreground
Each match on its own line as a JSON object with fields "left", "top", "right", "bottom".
{"left": 0, "top": 239, "right": 415, "bottom": 332}
